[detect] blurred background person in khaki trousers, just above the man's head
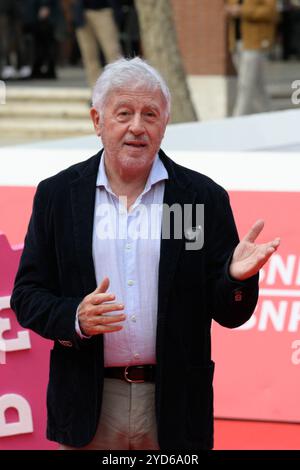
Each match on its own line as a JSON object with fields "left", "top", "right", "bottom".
{"left": 73, "top": 0, "right": 122, "bottom": 88}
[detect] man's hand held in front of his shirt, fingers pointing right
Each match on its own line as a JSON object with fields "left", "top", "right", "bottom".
{"left": 78, "top": 277, "right": 126, "bottom": 336}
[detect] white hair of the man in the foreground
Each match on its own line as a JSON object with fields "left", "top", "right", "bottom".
{"left": 92, "top": 57, "right": 171, "bottom": 116}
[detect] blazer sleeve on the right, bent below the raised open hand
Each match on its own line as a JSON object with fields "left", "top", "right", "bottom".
{"left": 209, "top": 190, "right": 258, "bottom": 328}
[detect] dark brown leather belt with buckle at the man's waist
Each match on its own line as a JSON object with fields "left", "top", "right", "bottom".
{"left": 104, "top": 364, "right": 156, "bottom": 383}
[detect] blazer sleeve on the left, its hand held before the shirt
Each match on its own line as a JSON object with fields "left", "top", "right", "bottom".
{"left": 11, "top": 180, "right": 82, "bottom": 344}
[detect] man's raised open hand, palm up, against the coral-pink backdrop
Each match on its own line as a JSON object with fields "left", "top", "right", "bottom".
{"left": 229, "top": 220, "right": 280, "bottom": 281}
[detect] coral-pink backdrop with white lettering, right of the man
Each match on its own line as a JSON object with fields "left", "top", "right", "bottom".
{"left": 213, "top": 192, "right": 300, "bottom": 422}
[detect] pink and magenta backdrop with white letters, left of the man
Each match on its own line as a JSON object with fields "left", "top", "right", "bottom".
{"left": 0, "top": 187, "right": 57, "bottom": 450}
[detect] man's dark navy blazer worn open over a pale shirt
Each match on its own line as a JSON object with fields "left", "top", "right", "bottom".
{"left": 11, "top": 151, "right": 258, "bottom": 450}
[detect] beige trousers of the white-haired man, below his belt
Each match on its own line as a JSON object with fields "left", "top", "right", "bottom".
{"left": 59, "top": 379, "right": 159, "bottom": 450}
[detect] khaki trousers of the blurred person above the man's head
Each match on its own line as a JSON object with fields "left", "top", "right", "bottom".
{"left": 76, "top": 8, "right": 122, "bottom": 87}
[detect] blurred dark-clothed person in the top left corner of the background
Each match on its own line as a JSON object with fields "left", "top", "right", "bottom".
{"left": 0, "top": 0, "right": 31, "bottom": 80}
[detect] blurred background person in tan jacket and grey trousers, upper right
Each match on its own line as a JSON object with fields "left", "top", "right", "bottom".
{"left": 225, "top": 0, "right": 278, "bottom": 116}
